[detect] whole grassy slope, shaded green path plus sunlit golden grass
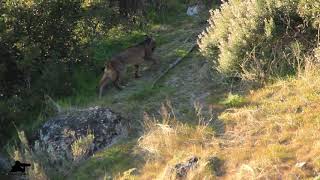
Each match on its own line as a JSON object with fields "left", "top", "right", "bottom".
{"left": 43, "top": 10, "right": 320, "bottom": 179}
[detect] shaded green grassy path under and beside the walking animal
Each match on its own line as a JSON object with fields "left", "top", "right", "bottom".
{"left": 69, "top": 12, "right": 232, "bottom": 179}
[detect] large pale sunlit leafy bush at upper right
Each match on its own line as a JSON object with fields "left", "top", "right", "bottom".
{"left": 198, "top": 0, "right": 320, "bottom": 79}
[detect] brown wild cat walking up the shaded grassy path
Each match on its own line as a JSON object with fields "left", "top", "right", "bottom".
{"left": 99, "top": 36, "right": 158, "bottom": 97}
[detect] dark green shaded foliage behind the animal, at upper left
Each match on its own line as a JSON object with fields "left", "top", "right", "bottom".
{"left": 0, "top": 0, "right": 154, "bottom": 144}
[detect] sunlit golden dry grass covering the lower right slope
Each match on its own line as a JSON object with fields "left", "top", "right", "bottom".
{"left": 117, "top": 60, "right": 320, "bottom": 179}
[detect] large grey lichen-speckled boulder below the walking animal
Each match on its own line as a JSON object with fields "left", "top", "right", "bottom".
{"left": 33, "top": 107, "right": 127, "bottom": 164}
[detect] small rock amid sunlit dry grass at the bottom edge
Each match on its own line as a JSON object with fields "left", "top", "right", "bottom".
{"left": 171, "top": 156, "right": 199, "bottom": 179}
